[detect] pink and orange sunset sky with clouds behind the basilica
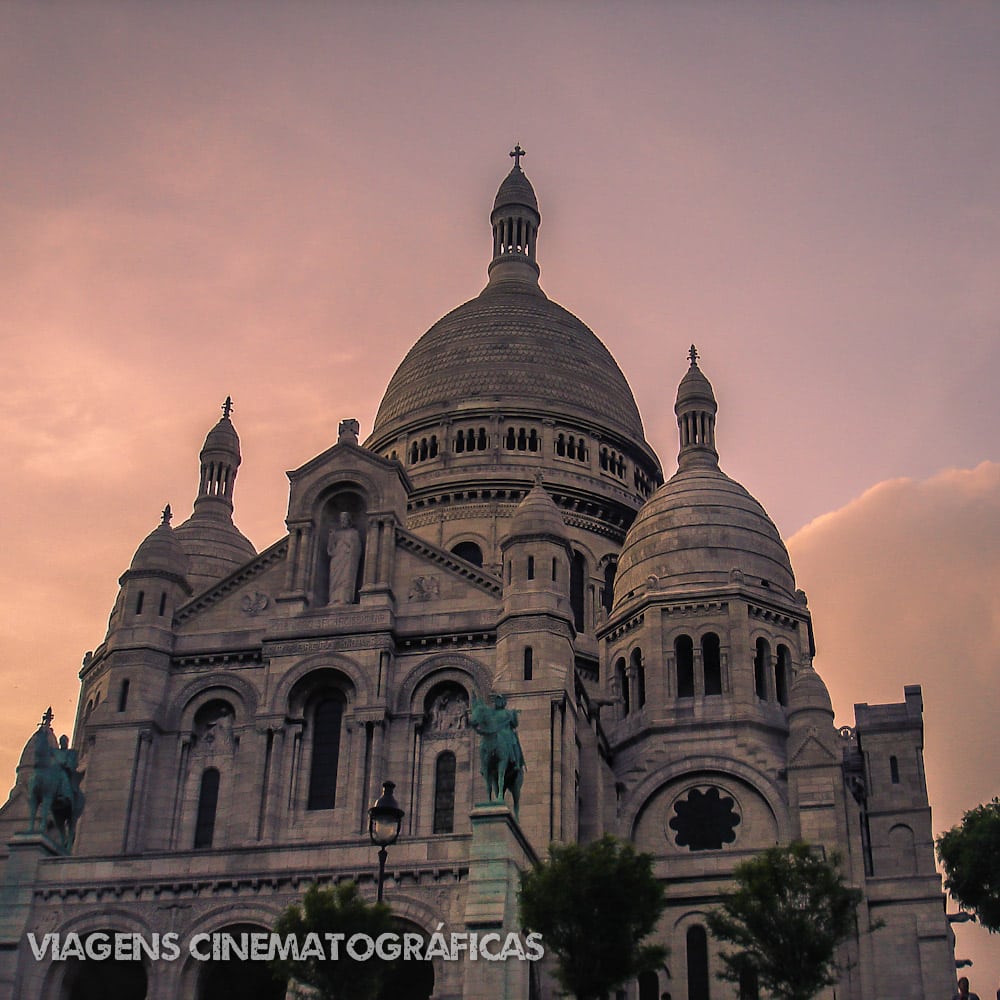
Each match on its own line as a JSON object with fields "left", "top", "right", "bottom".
{"left": 0, "top": 0, "right": 1000, "bottom": 984}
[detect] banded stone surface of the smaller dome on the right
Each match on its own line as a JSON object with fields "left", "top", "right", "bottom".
{"left": 615, "top": 467, "right": 795, "bottom": 605}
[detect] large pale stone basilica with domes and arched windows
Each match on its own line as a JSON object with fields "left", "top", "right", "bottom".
{"left": 0, "top": 147, "right": 954, "bottom": 1000}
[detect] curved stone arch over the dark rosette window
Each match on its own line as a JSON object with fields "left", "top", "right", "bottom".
{"left": 618, "top": 755, "right": 794, "bottom": 843}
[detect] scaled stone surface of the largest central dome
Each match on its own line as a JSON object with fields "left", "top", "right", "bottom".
{"left": 373, "top": 282, "right": 643, "bottom": 440}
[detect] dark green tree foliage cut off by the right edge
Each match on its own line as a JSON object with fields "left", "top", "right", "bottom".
{"left": 937, "top": 798, "right": 1000, "bottom": 934}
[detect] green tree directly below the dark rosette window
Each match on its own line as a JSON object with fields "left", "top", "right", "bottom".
{"left": 707, "top": 841, "right": 861, "bottom": 1000}
